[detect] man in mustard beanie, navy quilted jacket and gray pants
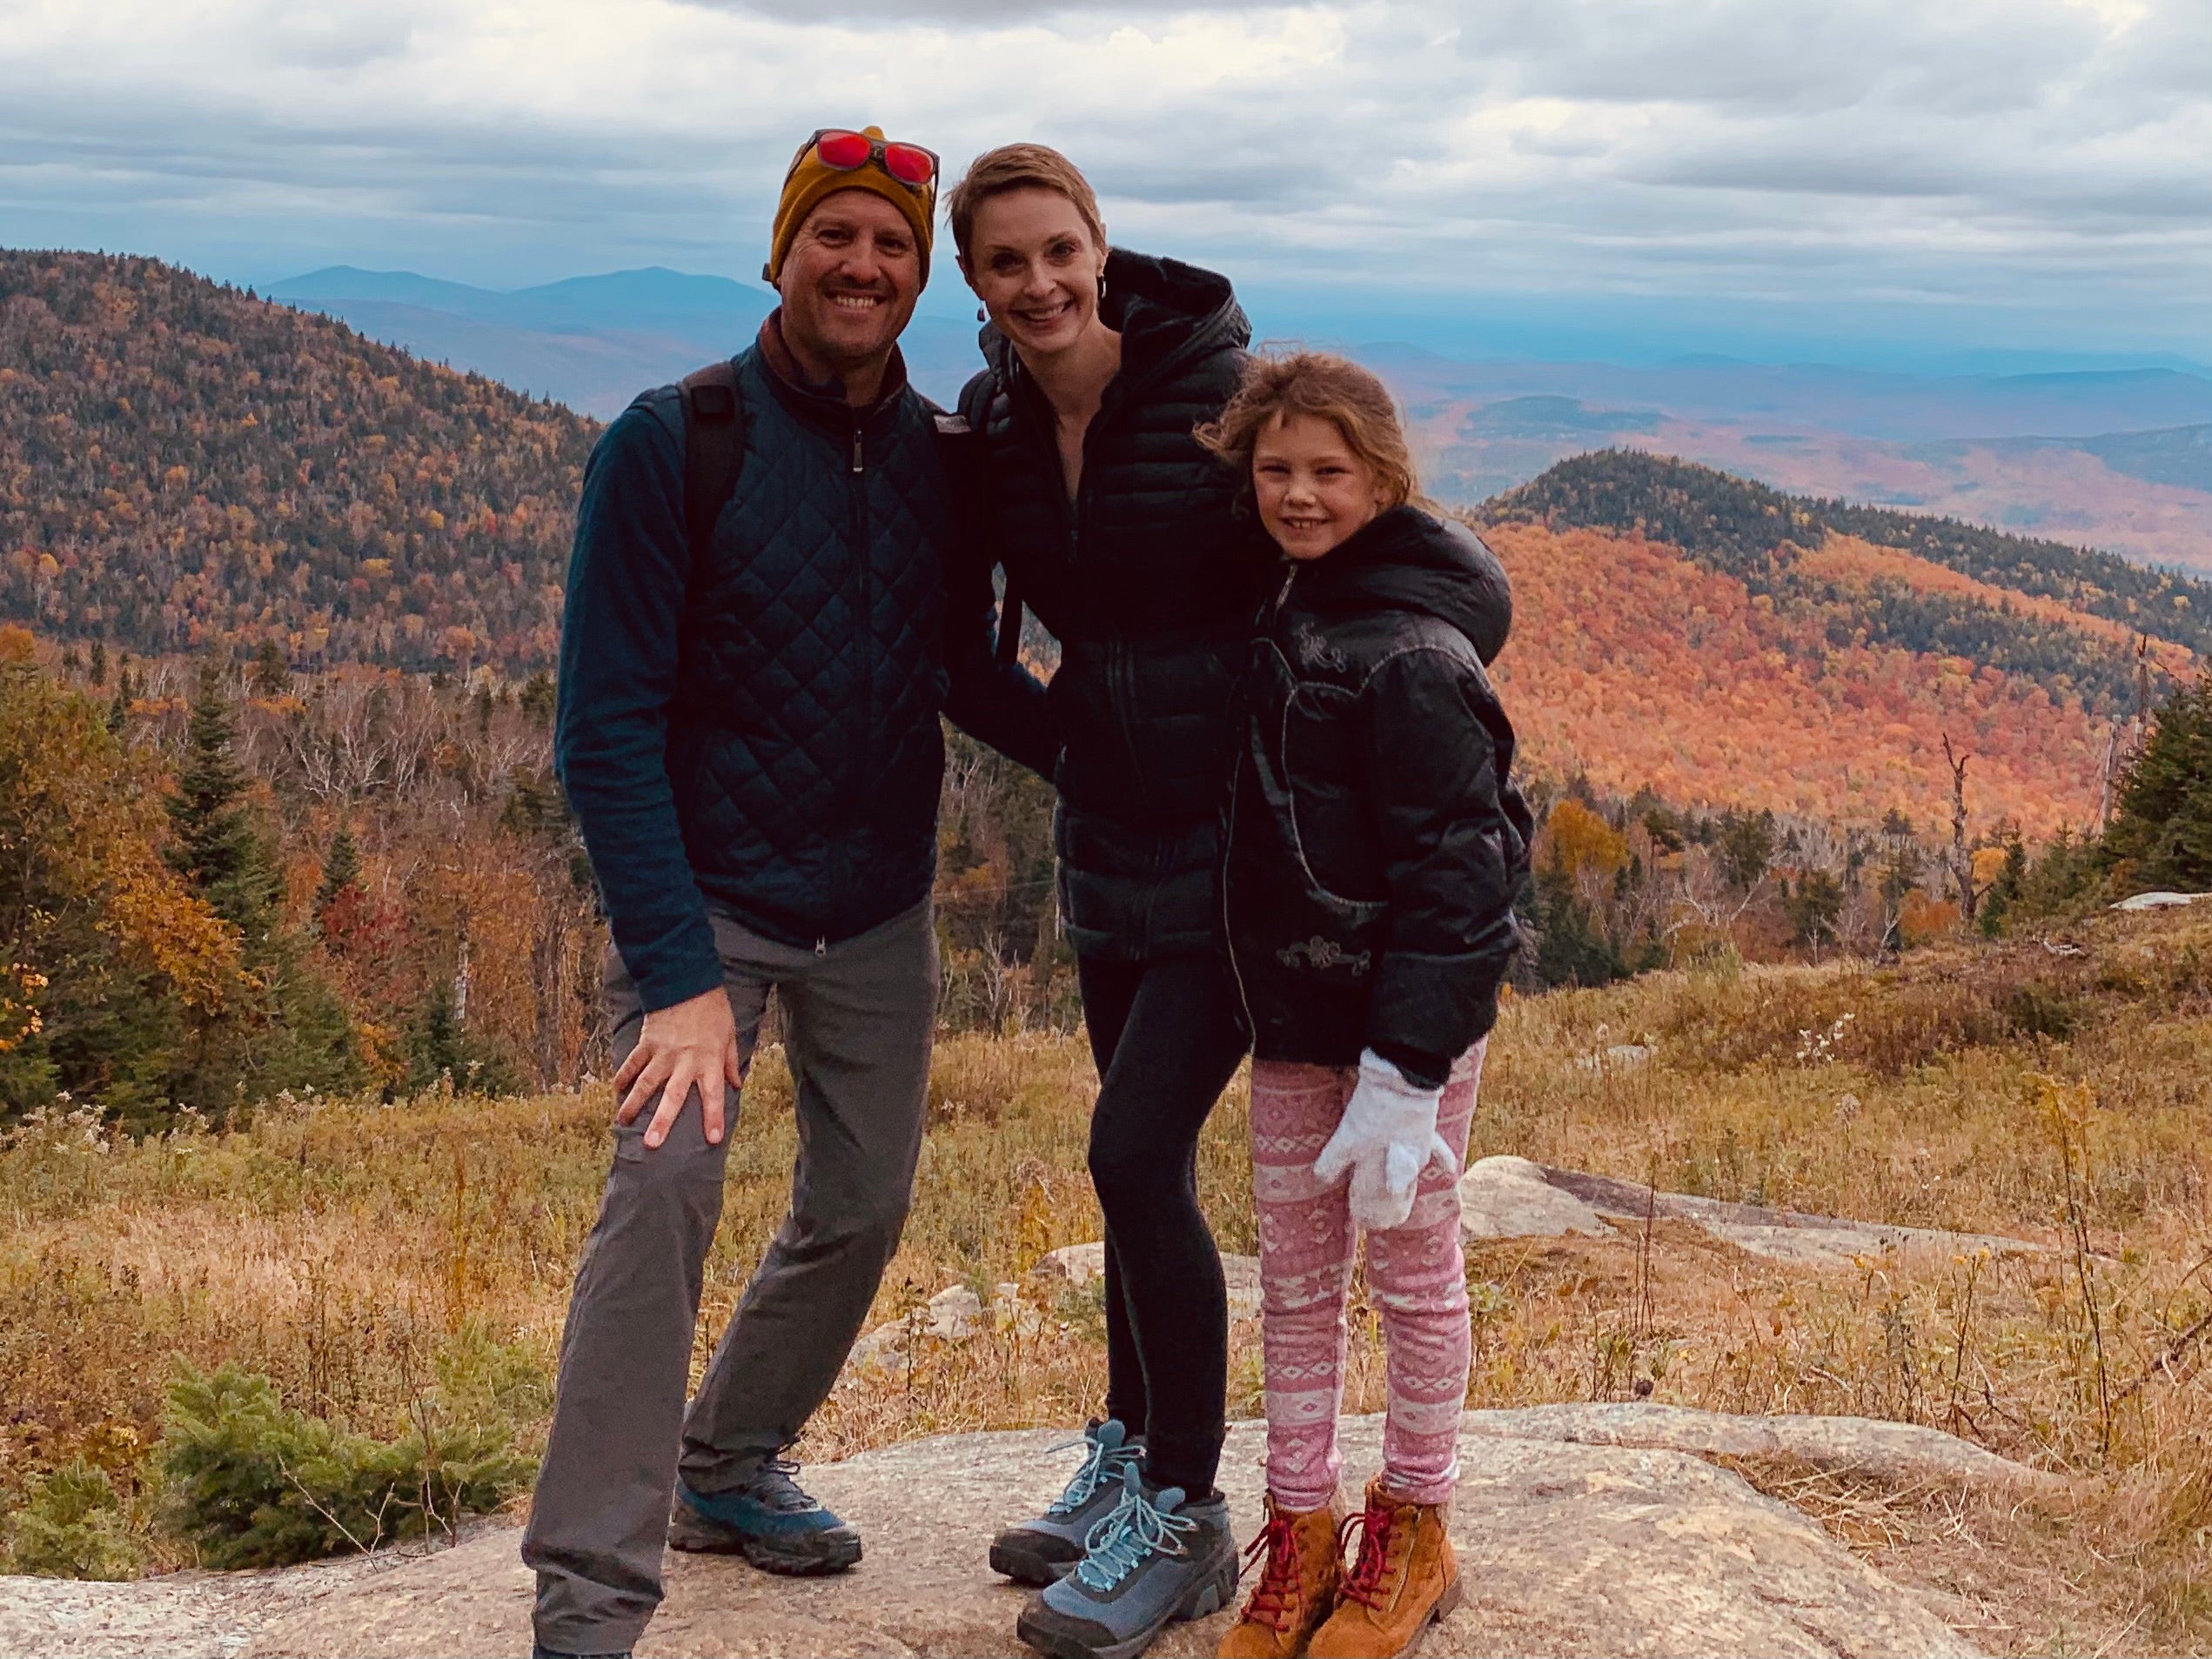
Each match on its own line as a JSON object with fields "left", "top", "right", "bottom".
{"left": 522, "top": 128, "right": 1053, "bottom": 1655}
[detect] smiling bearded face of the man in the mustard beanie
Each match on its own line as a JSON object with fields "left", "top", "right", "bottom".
{"left": 776, "top": 191, "right": 922, "bottom": 393}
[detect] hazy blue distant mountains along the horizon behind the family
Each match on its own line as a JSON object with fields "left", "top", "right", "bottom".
{"left": 265, "top": 265, "right": 2212, "bottom": 568}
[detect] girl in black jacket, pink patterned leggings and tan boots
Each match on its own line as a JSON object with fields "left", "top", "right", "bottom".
{"left": 1201, "top": 354, "right": 1531, "bottom": 1656}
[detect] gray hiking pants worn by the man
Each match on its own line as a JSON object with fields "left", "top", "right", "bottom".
{"left": 522, "top": 902, "right": 938, "bottom": 1652}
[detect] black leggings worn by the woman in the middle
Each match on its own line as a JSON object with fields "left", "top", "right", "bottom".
{"left": 1077, "top": 955, "right": 1245, "bottom": 1495}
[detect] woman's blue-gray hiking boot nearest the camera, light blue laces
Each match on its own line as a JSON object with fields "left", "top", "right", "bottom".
{"left": 1016, "top": 1468, "right": 1237, "bottom": 1659}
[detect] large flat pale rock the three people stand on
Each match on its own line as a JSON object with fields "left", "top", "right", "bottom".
{"left": 0, "top": 1407, "right": 1973, "bottom": 1659}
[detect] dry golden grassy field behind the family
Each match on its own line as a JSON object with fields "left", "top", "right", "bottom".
{"left": 0, "top": 913, "right": 2212, "bottom": 1652}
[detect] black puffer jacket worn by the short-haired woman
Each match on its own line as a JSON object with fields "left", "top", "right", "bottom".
{"left": 960, "top": 250, "right": 1277, "bottom": 960}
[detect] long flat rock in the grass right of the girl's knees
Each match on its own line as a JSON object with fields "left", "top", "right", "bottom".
{"left": 1460, "top": 1157, "right": 2044, "bottom": 1268}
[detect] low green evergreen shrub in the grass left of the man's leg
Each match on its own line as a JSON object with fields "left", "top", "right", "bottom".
{"left": 162, "top": 1361, "right": 531, "bottom": 1566}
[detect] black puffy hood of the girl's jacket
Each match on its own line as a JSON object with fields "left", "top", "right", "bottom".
{"left": 1298, "top": 506, "right": 1513, "bottom": 668}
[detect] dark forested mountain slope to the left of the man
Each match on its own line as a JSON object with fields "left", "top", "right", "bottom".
{"left": 0, "top": 250, "right": 597, "bottom": 670}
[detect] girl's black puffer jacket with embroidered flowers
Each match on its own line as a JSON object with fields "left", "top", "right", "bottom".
{"left": 1223, "top": 506, "right": 1533, "bottom": 1084}
